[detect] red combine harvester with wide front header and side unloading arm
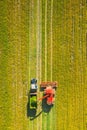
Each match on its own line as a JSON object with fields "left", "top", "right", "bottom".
{"left": 39, "top": 81, "right": 57, "bottom": 105}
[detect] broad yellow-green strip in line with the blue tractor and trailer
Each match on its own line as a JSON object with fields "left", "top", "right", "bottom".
{"left": 29, "top": 0, "right": 37, "bottom": 130}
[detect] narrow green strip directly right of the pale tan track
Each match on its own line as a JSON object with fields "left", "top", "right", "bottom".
{"left": 41, "top": 0, "right": 47, "bottom": 130}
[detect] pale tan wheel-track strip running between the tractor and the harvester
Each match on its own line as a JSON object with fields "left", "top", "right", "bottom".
{"left": 36, "top": 0, "right": 42, "bottom": 130}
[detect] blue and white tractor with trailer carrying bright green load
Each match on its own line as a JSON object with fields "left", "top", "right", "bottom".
{"left": 30, "top": 79, "right": 37, "bottom": 109}
